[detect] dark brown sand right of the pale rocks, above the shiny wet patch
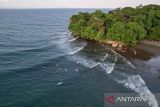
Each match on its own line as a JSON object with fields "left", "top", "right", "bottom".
{"left": 104, "top": 40, "right": 160, "bottom": 61}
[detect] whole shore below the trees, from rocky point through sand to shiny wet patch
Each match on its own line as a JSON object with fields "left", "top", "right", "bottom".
{"left": 70, "top": 32, "right": 160, "bottom": 79}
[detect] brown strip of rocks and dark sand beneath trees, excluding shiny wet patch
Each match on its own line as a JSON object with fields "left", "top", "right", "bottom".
{"left": 74, "top": 36, "right": 160, "bottom": 61}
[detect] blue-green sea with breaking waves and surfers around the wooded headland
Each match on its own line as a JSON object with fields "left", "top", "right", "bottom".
{"left": 0, "top": 9, "right": 160, "bottom": 107}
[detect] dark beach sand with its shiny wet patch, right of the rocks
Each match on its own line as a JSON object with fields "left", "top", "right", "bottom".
{"left": 121, "top": 43, "right": 160, "bottom": 79}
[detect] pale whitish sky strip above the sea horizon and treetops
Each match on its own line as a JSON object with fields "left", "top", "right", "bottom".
{"left": 0, "top": 0, "right": 160, "bottom": 8}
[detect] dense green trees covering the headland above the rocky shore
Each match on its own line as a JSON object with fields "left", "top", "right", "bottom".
{"left": 69, "top": 5, "right": 160, "bottom": 45}
